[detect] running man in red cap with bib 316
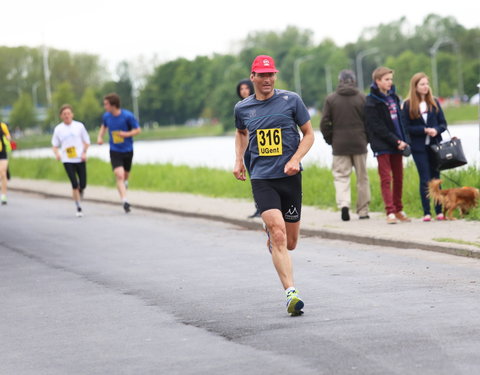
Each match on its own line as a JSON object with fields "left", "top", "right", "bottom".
{"left": 233, "top": 55, "right": 314, "bottom": 315}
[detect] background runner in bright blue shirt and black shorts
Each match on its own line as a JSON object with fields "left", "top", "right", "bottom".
{"left": 97, "top": 93, "right": 141, "bottom": 213}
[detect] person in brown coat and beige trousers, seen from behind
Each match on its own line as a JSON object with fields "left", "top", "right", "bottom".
{"left": 320, "top": 70, "right": 370, "bottom": 221}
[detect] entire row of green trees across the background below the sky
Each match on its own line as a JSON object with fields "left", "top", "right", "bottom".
{"left": 0, "top": 15, "right": 480, "bottom": 132}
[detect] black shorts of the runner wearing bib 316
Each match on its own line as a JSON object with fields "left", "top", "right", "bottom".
{"left": 252, "top": 173, "right": 302, "bottom": 223}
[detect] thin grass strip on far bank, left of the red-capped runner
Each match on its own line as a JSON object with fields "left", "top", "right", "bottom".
{"left": 16, "top": 124, "right": 223, "bottom": 150}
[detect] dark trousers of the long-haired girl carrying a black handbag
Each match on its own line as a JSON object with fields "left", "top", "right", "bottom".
{"left": 412, "top": 147, "right": 442, "bottom": 215}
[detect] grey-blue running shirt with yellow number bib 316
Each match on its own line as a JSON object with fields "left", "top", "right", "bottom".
{"left": 234, "top": 89, "right": 310, "bottom": 180}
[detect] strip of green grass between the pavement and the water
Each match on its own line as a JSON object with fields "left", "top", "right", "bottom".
{"left": 10, "top": 157, "right": 480, "bottom": 220}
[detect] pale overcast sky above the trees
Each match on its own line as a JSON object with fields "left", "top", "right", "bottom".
{"left": 0, "top": 0, "right": 480, "bottom": 71}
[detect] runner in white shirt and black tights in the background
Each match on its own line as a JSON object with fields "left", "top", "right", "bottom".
{"left": 52, "top": 104, "right": 90, "bottom": 217}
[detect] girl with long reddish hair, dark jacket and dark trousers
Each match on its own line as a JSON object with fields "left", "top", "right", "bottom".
{"left": 403, "top": 73, "right": 447, "bottom": 221}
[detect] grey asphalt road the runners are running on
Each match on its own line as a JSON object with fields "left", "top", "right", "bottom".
{"left": 0, "top": 193, "right": 480, "bottom": 375}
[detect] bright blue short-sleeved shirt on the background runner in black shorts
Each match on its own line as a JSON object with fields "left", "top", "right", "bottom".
{"left": 102, "top": 108, "right": 140, "bottom": 152}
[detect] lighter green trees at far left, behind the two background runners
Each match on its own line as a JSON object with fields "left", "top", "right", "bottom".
{"left": 0, "top": 47, "right": 132, "bottom": 129}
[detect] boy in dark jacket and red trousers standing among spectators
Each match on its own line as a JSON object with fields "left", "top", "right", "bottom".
{"left": 365, "top": 67, "right": 410, "bottom": 224}
